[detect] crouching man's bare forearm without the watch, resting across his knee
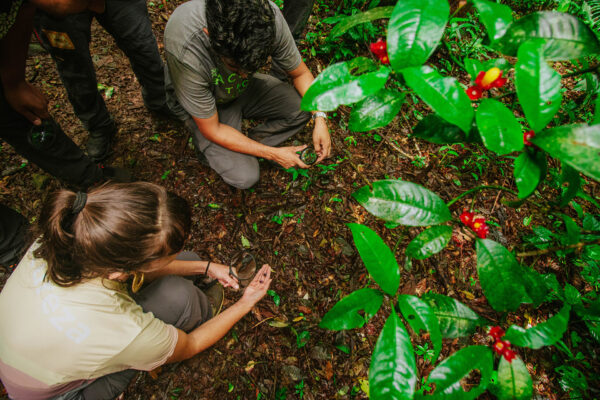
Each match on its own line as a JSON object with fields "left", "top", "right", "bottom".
{"left": 193, "top": 113, "right": 308, "bottom": 168}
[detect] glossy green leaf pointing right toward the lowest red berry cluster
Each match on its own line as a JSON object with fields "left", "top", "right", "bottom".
{"left": 421, "top": 292, "right": 485, "bottom": 339}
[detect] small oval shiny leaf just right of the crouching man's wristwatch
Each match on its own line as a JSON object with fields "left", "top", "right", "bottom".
{"left": 348, "top": 89, "right": 406, "bottom": 132}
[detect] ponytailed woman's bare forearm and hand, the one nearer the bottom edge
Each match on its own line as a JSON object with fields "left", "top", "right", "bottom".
{"left": 162, "top": 264, "right": 271, "bottom": 363}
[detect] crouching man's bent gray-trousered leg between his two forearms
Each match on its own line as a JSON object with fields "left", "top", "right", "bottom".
{"left": 239, "top": 74, "right": 310, "bottom": 146}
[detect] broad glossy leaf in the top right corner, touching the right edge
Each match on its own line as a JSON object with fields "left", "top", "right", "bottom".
{"left": 497, "top": 11, "right": 600, "bottom": 61}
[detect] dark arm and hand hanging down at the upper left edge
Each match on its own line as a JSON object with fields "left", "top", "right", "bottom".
{"left": 0, "top": 3, "right": 49, "bottom": 125}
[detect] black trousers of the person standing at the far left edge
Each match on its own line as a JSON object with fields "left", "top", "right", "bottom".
{"left": 0, "top": 84, "right": 103, "bottom": 266}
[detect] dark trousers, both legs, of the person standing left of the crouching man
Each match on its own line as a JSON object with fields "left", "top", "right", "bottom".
{"left": 35, "top": 0, "right": 166, "bottom": 134}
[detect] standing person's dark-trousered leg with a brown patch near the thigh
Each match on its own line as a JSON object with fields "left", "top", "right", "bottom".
{"left": 36, "top": 11, "right": 116, "bottom": 161}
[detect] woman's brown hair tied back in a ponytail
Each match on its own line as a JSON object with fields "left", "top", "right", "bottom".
{"left": 35, "top": 182, "right": 190, "bottom": 286}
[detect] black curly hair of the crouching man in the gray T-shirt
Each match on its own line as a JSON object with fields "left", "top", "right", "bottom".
{"left": 206, "top": 0, "right": 275, "bottom": 74}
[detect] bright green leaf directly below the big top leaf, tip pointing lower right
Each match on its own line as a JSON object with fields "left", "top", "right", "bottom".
{"left": 398, "top": 65, "right": 474, "bottom": 133}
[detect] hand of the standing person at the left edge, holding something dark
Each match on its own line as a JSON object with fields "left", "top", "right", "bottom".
{"left": 4, "top": 81, "right": 50, "bottom": 125}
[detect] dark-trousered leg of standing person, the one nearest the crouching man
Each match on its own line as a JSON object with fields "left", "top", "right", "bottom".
{"left": 96, "top": 0, "right": 166, "bottom": 112}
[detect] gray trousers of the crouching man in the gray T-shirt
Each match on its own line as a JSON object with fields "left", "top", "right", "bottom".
{"left": 186, "top": 74, "right": 310, "bottom": 189}
